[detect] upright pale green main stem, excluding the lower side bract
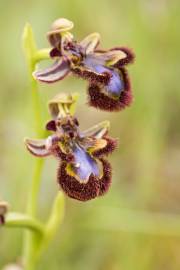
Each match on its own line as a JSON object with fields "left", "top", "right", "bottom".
{"left": 23, "top": 24, "right": 49, "bottom": 270}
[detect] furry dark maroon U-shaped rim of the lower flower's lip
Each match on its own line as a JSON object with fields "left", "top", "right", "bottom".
{"left": 58, "top": 159, "right": 111, "bottom": 201}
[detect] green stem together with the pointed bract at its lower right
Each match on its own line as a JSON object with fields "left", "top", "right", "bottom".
{"left": 21, "top": 24, "right": 64, "bottom": 270}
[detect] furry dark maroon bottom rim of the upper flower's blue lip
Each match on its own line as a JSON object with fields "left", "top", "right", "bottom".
{"left": 88, "top": 68, "right": 133, "bottom": 111}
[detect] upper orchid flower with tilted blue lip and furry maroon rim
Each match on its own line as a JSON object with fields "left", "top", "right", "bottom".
{"left": 33, "top": 19, "right": 134, "bottom": 111}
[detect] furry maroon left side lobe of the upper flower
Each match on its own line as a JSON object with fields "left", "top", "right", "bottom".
{"left": 71, "top": 67, "right": 111, "bottom": 85}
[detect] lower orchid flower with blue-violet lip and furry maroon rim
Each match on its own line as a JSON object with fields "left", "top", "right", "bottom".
{"left": 25, "top": 95, "right": 117, "bottom": 201}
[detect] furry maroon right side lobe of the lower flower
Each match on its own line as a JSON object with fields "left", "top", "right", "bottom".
{"left": 93, "top": 136, "right": 118, "bottom": 157}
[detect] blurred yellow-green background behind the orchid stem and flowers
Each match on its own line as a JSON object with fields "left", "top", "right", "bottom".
{"left": 0, "top": 0, "right": 180, "bottom": 270}
